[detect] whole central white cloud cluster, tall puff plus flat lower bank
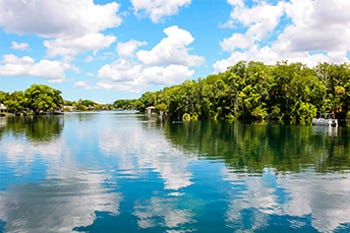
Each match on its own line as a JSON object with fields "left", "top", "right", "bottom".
{"left": 97, "top": 26, "right": 204, "bottom": 92}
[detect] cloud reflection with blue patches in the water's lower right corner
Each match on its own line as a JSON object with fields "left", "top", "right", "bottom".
{"left": 222, "top": 169, "right": 350, "bottom": 232}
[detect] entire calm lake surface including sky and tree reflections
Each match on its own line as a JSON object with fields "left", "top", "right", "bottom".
{"left": 0, "top": 112, "right": 350, "bottom": 233}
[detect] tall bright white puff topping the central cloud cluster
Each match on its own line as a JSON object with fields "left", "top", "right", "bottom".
{"left": 136, "top": 26, "right": 204, "bottom": 66}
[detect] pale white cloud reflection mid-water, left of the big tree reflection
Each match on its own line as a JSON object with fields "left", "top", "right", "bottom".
{"left": 99, "top": 118, "right": 193, "bottom": 191}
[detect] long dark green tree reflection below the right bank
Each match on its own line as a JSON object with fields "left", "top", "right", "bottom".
{"left": 164, "top": 121, "right": 350, "bottom": 173}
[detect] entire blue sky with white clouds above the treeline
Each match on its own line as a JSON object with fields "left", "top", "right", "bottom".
{"left": 0, "top": 0, "right": 350, "bottom": 103}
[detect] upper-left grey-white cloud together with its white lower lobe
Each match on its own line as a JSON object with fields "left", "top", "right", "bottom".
{"left": 0, "top": 0, "right": 122, "bottom": 57}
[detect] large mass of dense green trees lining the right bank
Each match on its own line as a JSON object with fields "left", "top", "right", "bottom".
{"left": 136, "top": 61, "right": 350, "bottom": 124}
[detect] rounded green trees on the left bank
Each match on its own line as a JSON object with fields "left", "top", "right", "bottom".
{"left": 0, "top": 84, "right": 63, "bottom": 114}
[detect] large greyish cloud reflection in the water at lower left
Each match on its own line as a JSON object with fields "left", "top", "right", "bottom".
{"left": 0, "top": 132, "right": 122, "bottom": 233}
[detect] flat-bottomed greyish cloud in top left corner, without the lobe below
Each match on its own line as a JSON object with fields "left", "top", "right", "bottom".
{"left": 0, "top": 0, "right": 121, "bottom": 37}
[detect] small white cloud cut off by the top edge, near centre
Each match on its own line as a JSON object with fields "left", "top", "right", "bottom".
{"left": 131, "top": 0, "right": 191, "bottom": 22}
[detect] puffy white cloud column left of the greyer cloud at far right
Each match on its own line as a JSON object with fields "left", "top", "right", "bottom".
{"left": 213, "top": 0, "right": 285, "bottom": 72}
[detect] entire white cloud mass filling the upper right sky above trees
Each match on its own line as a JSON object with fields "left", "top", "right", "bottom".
{"left": 213, "top": 0, "right": 350, "bottom": 72}
